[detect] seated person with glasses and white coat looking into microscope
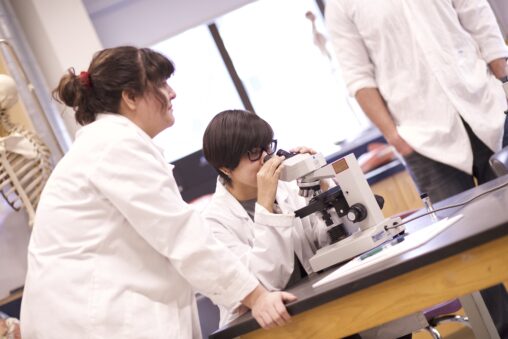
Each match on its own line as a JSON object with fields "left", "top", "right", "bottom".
{"left": 203, "top": 110, "right": 416, "bottom": 339}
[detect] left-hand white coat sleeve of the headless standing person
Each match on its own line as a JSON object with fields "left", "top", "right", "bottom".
{"left": 325, "top": 0, "right": 377, "bottom": 96}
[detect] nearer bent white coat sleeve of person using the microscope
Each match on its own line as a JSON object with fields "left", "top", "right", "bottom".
{"left": 205, "top": 204, "right": 295, "bottom": 291}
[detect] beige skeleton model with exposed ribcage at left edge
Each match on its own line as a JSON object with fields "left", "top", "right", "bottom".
{"left": 0, "top": 74, "right": 52, "bottom": 227}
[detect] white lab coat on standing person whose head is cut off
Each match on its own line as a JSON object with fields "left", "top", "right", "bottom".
{"left": 326, "top": 0, "right": 508, "bottom": 174}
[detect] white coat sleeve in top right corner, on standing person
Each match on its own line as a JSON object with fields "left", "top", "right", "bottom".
{"left": 452, "top": 0, "right": 508, "bottom": 63}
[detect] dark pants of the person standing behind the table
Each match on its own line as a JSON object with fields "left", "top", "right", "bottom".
{"left": 405, "top": 119, "right": 508, "bottom": 339}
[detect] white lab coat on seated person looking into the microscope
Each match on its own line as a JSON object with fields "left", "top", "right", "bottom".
{"left": 203, "top": 179, "right": 329, "bottom": 326}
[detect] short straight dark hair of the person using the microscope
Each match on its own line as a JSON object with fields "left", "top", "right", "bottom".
{"left": 203, "top": 110, "right": 273, "bottom": 185}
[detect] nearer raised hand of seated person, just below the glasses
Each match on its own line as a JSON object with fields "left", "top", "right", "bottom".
{"left": 257, "top": 156, "right": 284, "bottom": 213}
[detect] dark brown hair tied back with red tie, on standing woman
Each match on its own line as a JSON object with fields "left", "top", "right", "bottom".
{"left": 53, "top": 46, "right": 175, "bottom": 125}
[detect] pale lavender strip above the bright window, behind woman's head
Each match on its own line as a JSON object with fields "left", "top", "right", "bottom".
{"left": 83, "top": 0, "right": 253, "bottom": 47}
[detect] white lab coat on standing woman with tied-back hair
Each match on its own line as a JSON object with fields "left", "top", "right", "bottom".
{"left": 21, "top": 114, "right": 258, "bottom": 339}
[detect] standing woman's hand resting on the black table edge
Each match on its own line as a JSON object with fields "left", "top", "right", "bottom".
{"left": 242, "top": 285, "right": 297, "bottom": 329}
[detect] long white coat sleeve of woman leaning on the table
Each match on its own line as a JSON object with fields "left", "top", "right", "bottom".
{"left": 89, "top": 137, "right": 258, "bottom": 308}
